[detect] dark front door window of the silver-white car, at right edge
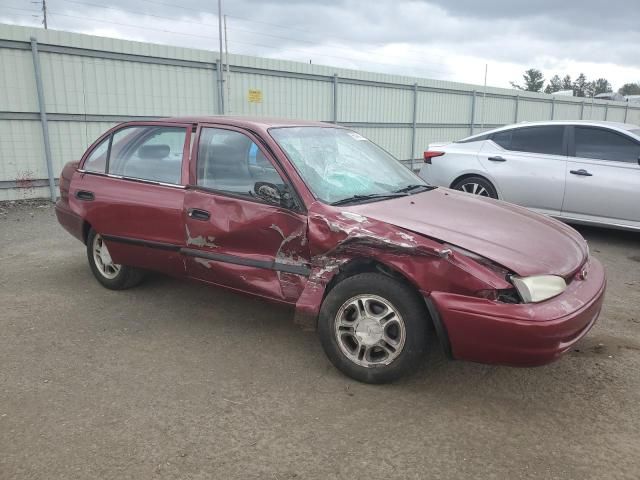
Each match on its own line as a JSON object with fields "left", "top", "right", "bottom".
{"left": 575, "top": 127, "right": 640, "bottom": 163}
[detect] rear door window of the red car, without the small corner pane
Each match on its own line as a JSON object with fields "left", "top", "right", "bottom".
{"left": 109, "top": 126, "right": 187, "bottom": 184}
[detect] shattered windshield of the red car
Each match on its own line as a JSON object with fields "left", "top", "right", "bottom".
{"left": 269, "top": 127, "right": 427, "bottom": 203}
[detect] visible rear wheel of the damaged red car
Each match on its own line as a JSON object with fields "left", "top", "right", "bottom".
{"left": 87, "top": 229, "right": 144, "bottom": 290}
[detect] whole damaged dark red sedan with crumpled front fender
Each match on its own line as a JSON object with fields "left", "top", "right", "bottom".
{"left": 56, "top": 117, "right": 605, "bottom": 383}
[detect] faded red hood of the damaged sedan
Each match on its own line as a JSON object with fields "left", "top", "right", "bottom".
{"left": 344, "top": 188, "right": 588, "bottom": 277}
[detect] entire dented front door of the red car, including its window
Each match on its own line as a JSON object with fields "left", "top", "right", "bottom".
{"left": 182, "top": 126, "right": 309, "bottom": 303}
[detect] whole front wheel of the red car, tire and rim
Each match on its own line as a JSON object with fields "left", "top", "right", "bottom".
{"left": 318, "top": 273, "right": 428, "bottom": 383}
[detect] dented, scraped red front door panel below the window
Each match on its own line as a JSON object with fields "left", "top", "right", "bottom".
{"left": 183, "top": 189, "right": 308, "bottom": 303}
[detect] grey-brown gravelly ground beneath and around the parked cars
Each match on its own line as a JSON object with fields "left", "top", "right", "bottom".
{"left": 0, "top": 203, "right": 640, "bottom": 480}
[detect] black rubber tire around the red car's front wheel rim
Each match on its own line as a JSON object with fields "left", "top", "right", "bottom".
{"left": 318, "top": 273, "right": 430, "bottom": 383}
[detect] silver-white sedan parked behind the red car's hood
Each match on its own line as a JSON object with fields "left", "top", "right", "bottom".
{"left": 420, "top": 120, "right": 640, "bottom": 230}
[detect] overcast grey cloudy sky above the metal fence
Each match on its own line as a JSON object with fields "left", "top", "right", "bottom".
{"left": 0, "top": 0, "right": 640, "bottom": 89}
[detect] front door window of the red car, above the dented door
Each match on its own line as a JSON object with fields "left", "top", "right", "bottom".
{"left": 197, "top": 128, "right": 286, "bottom": 198}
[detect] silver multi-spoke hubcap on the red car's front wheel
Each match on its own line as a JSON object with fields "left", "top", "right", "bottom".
{"left": 334, "top": 295, "right": 406, "bottom": 367}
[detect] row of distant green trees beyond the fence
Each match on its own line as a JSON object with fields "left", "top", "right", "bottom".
{"left": 509, "top": 68, "right": 640, "bottom": 97}
